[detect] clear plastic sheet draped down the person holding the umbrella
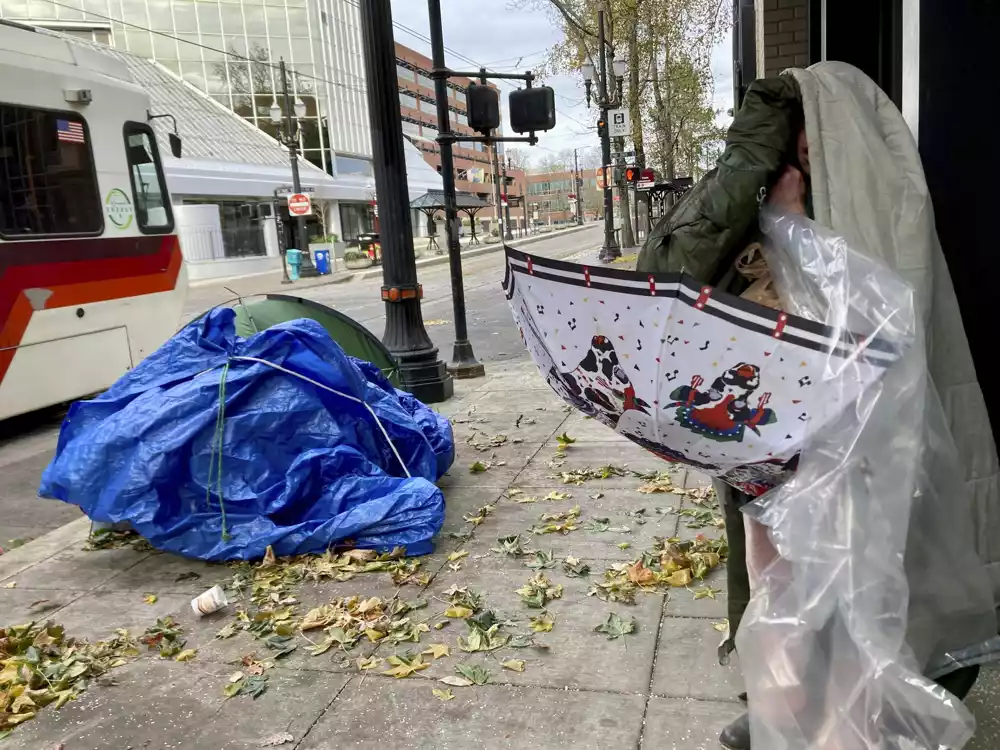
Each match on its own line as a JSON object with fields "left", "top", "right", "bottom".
{"left": 736, "top": 211, "right": 998, "bottom": 750}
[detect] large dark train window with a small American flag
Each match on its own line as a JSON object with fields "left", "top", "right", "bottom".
{"left": 0, "top": 104, "right": 104, "bottom": 237}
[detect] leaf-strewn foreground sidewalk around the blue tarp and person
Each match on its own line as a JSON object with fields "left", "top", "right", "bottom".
{"left": 0, "top": 364, "right": 1000, "bottom": 750}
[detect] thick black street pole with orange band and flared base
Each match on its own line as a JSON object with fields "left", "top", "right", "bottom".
{"left": 361, "top": 0, "right": 455, "bottom": 403}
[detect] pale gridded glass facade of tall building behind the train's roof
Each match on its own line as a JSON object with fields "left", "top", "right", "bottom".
{"left": 0, "top": 0, "right": 372, "bottom": 176}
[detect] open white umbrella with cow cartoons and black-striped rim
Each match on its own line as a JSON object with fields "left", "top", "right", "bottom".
{"left": 503, "top": 248, "right": 899, "bottom": 496}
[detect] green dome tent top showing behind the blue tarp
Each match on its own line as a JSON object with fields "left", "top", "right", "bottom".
{"left": 207, "top": 294, "right": 402, "bottom": 388}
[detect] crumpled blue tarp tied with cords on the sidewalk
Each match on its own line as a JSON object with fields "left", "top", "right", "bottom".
{"left": 39, "top": 308, "right": 455, "bottom": 560}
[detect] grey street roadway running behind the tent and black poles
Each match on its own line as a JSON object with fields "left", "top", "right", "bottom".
{"left": 0, "top": 224, "right": 602, "bottom": 549}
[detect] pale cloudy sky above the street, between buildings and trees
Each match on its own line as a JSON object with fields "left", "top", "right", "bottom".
{"left": 392, "top": 0, "right": 733, "bottom": 163}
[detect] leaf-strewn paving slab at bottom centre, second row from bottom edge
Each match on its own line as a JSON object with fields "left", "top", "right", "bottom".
{"left": 414, "top": 558, "right": 662, "bottom": 693}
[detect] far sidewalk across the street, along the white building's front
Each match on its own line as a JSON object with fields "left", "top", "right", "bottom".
{"left": 182, "top": 224, "right": 592, "bottom": 323}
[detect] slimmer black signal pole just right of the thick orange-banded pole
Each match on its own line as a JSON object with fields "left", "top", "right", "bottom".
{"left": 426, "top": 0, "right": 484, "bottom": 378}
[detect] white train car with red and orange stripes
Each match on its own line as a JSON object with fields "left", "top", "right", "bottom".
{"left": 0, "top": 21, "right": 187, "bottom": 419}
